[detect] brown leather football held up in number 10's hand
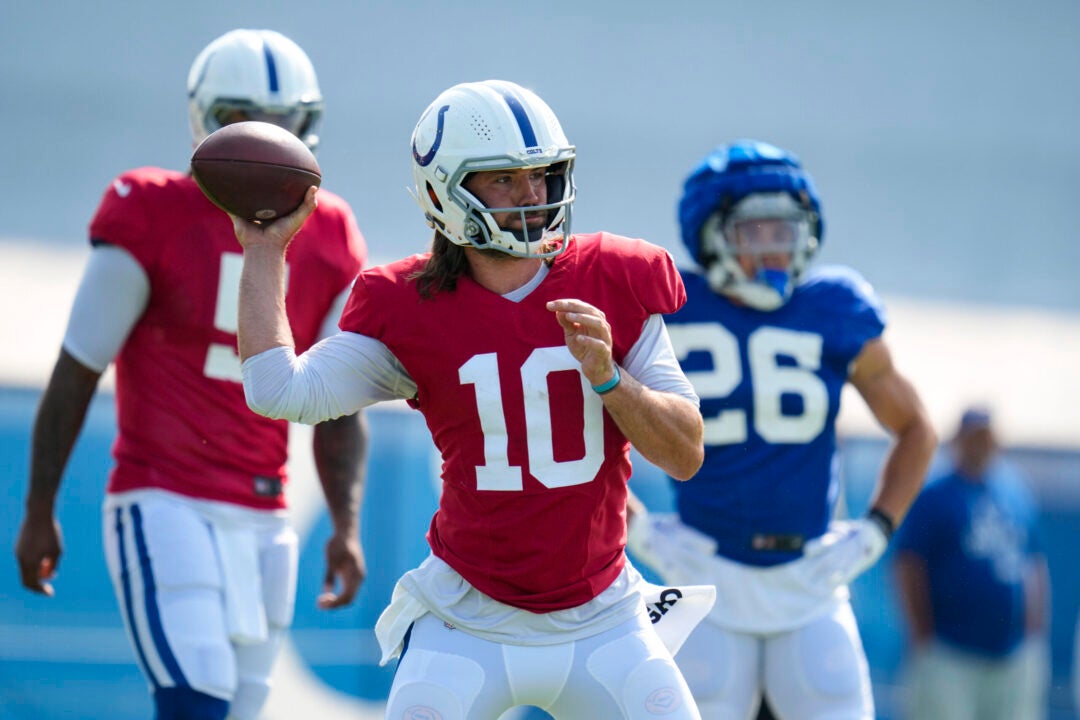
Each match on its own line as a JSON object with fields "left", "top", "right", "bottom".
{"left": 191, "top": 120, "right": 323, "bottom": 223}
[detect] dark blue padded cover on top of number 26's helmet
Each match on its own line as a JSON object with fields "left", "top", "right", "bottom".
{"left": 678, "top": 140, "right": 825, "bottom": 266}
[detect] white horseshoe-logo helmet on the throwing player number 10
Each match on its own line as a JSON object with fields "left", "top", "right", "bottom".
{"left": 413, "top": 80, "right": 575, "bottom": 257}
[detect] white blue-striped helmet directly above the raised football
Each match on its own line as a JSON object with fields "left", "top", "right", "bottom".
{"left": 188, "top": 30, "right": 323, "bottom": 150}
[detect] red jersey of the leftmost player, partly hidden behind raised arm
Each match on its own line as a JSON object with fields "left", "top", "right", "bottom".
{"left": 90, "top": 167, "right": 366, "bottom": 508}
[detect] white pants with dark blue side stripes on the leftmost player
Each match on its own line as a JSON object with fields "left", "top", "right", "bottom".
{"left": 102, "top": 490, "right": 297, "bottom": 720}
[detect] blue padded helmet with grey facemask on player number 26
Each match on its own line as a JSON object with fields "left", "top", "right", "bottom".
{"left": 678, "top": 140, "right": 824, "bottom": 310}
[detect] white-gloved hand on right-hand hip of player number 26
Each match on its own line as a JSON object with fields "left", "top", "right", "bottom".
{"left": 802, "top": 517, "right": 889, "bottom": 589}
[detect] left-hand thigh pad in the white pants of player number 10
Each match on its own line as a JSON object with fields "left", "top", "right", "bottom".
{"left": 387, "top": 648, "right": 484, "bottom": 720}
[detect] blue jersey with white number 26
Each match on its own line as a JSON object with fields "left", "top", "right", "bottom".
{"left": 665, "top": 267, "right": 885, "bottom": 566}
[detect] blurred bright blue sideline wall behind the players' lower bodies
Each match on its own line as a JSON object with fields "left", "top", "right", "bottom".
{"left": 0, "top": 390, "right": 1080, "bottom": 720}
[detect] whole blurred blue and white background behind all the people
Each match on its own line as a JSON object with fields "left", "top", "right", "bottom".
{"left": 0, "top": 0, "right": 1080, "bottom": 720}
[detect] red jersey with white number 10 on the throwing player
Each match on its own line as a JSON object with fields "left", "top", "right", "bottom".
{"left": 341, "top": 233, "right": 686, "bottom": 612}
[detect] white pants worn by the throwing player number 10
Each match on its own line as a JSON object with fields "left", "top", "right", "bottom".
{"left": 386, "top": 613, "right": 701, "bottom": 720}
